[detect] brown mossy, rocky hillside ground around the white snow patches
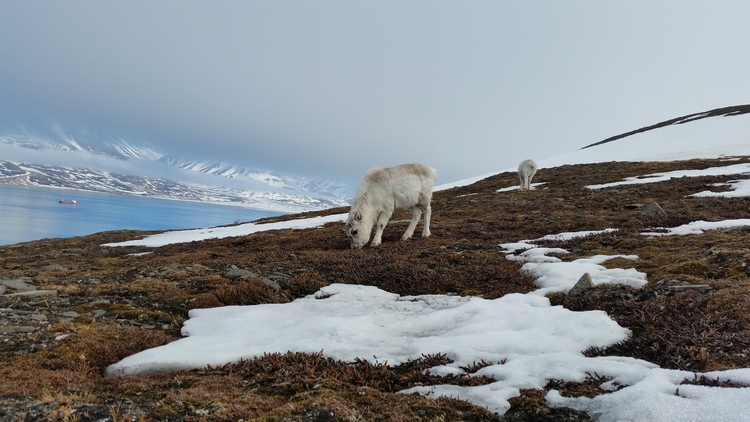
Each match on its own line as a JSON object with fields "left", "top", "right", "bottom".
{"left": 0, "top": 157, "right": 750, "bottom": 421}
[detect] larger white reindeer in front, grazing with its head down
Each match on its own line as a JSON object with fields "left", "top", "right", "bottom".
{"left": 346, "top": 164, "right": 437, "bottom": 249}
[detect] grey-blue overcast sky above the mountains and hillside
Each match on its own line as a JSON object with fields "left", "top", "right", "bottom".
{"left": 0, "top": 0, "right": 750, "bottom": 183}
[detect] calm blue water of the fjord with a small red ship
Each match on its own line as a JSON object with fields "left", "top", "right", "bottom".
{"left": 0, "top": 185, "right": 280, "bottom": 245}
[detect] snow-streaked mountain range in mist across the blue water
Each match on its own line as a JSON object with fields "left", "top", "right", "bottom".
{"left": 0, "top": 129, "right": 349, "bottom": 212}
